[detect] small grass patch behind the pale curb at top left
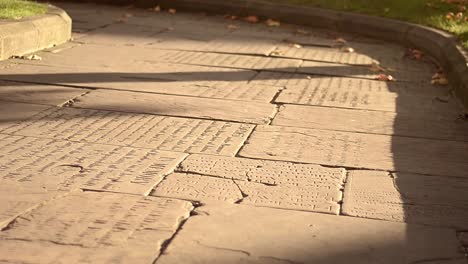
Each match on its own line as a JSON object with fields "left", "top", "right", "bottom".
{"left": 0, "top": 0, "right": 47, "bottom": 19}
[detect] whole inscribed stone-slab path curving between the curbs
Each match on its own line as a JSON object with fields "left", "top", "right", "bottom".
{"left": 0, "top": 3, "right": 468, "bottom": 264}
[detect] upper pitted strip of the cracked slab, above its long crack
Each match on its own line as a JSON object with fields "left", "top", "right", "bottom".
{"left": 177, "top": 154, "right": 346, "bottom": 189}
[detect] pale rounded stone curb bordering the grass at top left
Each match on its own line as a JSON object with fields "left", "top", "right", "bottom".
{"left": 0, "top": 5, "right": 72, "bottom": 60}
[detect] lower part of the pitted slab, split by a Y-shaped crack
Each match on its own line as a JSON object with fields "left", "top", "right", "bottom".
{"left": 152, "top": 173, "right": 342, "bottom": 215}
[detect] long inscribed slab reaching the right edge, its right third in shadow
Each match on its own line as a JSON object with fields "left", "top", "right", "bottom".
{"left": 239, "top": 126, "right": 468, "bottom": 177}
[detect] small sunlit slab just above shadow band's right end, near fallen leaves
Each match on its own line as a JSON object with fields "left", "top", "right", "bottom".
{"left": 272, "top": 45, "right": 375, "bottom": 65}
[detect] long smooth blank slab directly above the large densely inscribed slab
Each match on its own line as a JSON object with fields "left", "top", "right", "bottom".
{"left": 73, "top": 90, "right": 275, "bottom": 124}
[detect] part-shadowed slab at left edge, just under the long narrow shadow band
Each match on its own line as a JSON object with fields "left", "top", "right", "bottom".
{"left": 0, "top": 81, "right": 88, "bottom": 106}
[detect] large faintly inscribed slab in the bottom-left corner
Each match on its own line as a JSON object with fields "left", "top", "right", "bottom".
{"left": 0, "top": 192, "right": 192, "bottom": 263}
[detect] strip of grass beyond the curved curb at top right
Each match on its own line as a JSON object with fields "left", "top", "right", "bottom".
{"left": 273, "top": 0, "right": 468, "bottom": 48}
